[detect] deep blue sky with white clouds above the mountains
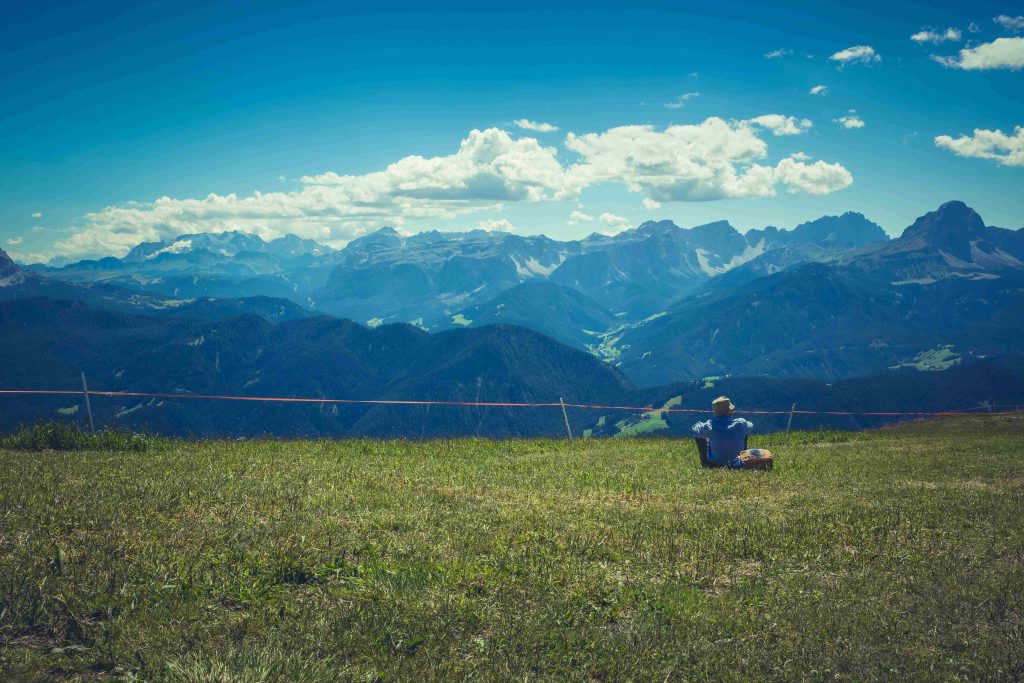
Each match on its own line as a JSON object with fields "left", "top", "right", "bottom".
{"left": 0, "top": 2, "right": 1024, "bottom": 261}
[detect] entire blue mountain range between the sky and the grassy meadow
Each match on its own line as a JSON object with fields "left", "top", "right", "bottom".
{"left": 0, "top": 197, "right": 1024, "bottom": 435}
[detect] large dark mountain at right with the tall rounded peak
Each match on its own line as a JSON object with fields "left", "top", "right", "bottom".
{"left": 620, "top": 202, "right": 1024, "bottom": 384}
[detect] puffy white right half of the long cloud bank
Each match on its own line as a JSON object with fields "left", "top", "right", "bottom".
{"left": 565, "top": 117, "right": 852, "bottom": 202}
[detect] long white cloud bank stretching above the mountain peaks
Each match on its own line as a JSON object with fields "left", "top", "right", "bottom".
{"left": 54, "top": 114, "right": 853, "bottom": 258}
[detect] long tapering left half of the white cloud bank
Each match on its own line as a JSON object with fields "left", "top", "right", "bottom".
{"left": 55, "top": 128, "right": 579, "bottom": 256}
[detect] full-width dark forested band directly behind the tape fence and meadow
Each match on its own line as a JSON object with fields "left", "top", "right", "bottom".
{"left": 0, "top": 296, "right": 1024, "bottom": 438}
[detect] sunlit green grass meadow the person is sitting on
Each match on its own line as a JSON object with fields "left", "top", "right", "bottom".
{"left": 0, "top": 416, "right": 1024, "bottom": 681}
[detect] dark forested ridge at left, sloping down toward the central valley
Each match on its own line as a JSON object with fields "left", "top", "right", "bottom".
{"left": 0, "top": 299, "right": 630, "bottom": 435}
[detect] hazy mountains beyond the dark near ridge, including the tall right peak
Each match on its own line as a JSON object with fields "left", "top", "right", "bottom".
{"left": 9, "top": 201, "right": 1024, "bottom": 385}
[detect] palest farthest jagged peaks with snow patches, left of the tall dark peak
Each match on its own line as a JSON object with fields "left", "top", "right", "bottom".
{"left": 24, "top": 208, "right": 886, "bottom": 330}
